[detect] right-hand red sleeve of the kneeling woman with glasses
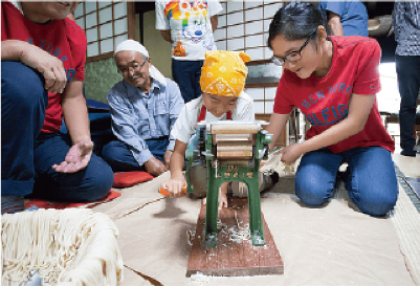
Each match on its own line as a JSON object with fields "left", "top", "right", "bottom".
{"left": 353, "top": 39, "right": 381, "bottom": 94}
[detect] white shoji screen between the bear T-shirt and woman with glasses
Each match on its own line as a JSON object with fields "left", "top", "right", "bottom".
{"left": 214, "top": 0, "right": 282, "bottom": 114}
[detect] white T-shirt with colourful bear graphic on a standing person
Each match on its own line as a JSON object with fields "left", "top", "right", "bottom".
{"left": 156, "top": 0, "right": 223, "bottom": 61}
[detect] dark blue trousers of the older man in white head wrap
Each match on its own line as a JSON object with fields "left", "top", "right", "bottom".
{"left": 102, "top": 137, "right": 169, "bottom": 172}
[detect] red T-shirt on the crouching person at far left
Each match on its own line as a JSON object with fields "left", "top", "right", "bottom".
{"left": 1, "top": 2, "right": 87, "bottom": 133}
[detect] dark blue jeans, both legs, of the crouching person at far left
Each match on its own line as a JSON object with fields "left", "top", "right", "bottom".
{"left": 1, "top": 62, "right": 113, "bottom": 202}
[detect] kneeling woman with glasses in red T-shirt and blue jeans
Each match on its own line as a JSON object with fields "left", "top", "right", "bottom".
{"left": 267, "top": 2, "right": 398, "bottom": 216}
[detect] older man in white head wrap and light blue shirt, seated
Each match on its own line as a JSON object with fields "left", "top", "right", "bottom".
{"left": 102, "top": 40, "right": 184, "bottom": 176}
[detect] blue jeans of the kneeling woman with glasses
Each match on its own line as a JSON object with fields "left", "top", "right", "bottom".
{"left": 295, "top": 147, "right": 398, "bottom": 216}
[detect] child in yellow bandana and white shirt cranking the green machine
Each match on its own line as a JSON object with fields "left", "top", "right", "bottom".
{"left": 163, "top": 51, "right": 278, "bottom": 210}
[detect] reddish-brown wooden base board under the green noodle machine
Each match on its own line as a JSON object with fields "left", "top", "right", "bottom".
{"left": 186, "top": 198, "right": 284, "bottom": 277}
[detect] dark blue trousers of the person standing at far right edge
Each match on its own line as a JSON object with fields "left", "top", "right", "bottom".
{"left": 395, "top": 55, "right": 420, "bottom": 156}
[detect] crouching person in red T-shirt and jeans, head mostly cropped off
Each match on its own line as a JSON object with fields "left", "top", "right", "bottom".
{"left": 1, "top": 2, "right": 113, "bottom": 213}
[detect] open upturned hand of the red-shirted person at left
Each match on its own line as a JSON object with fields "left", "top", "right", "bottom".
{"left": 51, "top": 140, "right": 93, "bottom": 173}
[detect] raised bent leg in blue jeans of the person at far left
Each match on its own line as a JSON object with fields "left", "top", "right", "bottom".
{"left": 1, "top": 61, "right": 48, "bottom": 196}
